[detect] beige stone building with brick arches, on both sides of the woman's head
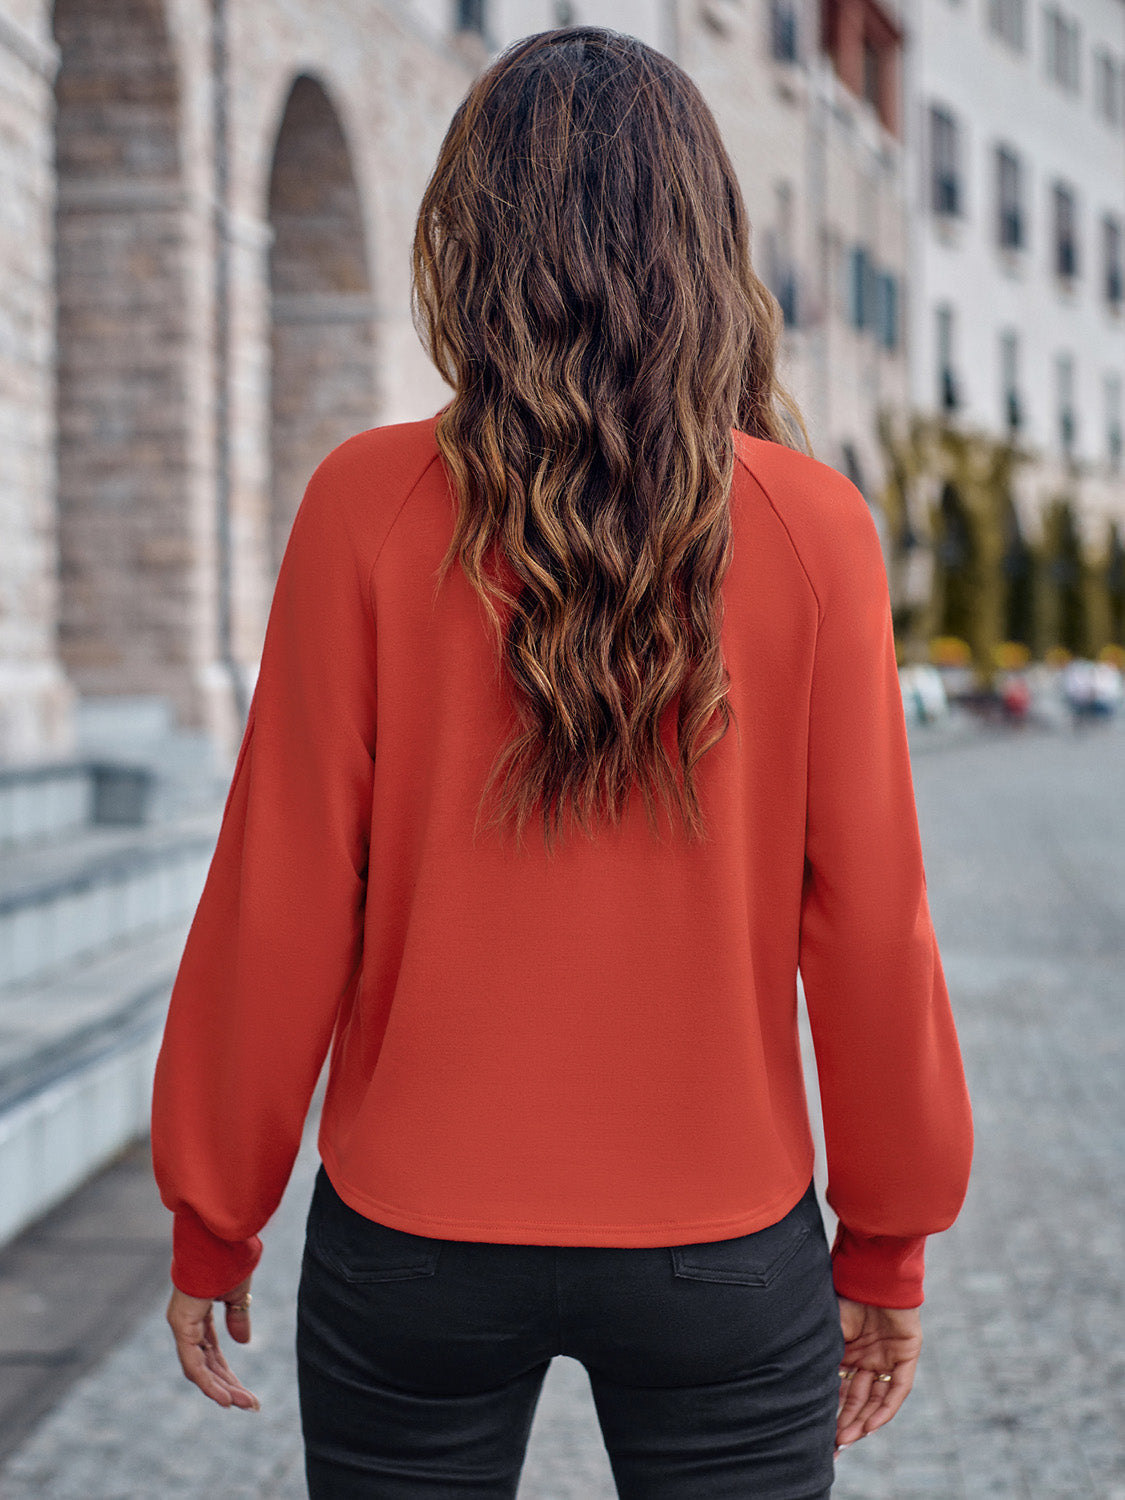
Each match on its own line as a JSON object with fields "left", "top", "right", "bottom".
{"left": 0, "top": 0, "right": 924, "bottom": 764}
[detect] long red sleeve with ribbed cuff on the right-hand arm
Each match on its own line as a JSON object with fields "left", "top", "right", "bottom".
{"left": 800, "top": 476, "right": 972, "bottom": 1308}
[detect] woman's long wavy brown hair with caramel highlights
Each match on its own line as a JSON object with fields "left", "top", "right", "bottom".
{"left": 413, "top": 26, "right": 809, "bottom": 849}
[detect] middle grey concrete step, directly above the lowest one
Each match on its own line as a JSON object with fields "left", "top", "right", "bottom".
{"left": 0, "top": 803, "right": 222, "bottom": 995}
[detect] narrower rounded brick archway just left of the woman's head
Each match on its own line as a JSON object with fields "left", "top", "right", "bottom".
{"left": 269, "top": 75, "right": 377, "bottom": 573}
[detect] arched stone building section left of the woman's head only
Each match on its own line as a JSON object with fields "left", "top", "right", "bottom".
{"left": 0, "top": 0, "right": 477, "bottom": 761}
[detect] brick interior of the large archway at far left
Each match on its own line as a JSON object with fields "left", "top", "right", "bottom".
{"left": 53, "top": 0, "right": 198, "bottom": 716}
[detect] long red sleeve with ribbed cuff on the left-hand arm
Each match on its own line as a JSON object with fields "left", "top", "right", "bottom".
{"left": 152, "top": 455, "right": 375, "bottom": 1298}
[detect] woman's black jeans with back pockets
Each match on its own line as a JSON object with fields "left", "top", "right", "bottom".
{"left": 297, "top": 1167, "right": 843, "bottom": 1500}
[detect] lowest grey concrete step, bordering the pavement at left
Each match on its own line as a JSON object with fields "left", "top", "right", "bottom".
{"left": 0, "top": 914, "right": 191, "bottom": 1244}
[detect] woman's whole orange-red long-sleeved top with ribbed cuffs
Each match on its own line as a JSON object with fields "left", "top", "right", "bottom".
{"left": 152, "top": 414, "right": 972, "bottom": 1307}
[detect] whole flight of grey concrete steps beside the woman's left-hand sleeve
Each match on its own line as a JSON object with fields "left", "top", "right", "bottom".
{"left": 0, "top": 698, "right": 231, "bottom": 1245}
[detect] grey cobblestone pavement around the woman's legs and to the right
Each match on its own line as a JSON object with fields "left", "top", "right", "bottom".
{"left": 0, "top": 726, "right": 1125, "bottom": 1500}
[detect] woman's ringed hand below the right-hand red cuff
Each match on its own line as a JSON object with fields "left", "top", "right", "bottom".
{"left": 836, "top": 1298, "right": 923, "bottom": 1454}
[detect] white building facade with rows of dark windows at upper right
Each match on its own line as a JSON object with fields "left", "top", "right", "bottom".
{"left": 906, "top": 0, "right": 1125, "bottom": 548}
